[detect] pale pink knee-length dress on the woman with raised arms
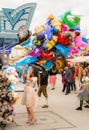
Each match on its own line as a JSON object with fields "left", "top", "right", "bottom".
{"left": 21, "top": 77, "right": 37, "bottom": 107}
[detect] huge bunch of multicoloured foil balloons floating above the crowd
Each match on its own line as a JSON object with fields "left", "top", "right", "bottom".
{"left": 13, "top": 11, "right": 88, "bottom": 70}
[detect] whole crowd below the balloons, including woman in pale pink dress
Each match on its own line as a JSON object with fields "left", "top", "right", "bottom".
{"left": 0, "top": 63, "right": 89, "bottom": 124}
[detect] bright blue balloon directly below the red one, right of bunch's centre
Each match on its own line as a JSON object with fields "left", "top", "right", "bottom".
{"left": 55, "top": 44, "right": 70, "bottom": 58}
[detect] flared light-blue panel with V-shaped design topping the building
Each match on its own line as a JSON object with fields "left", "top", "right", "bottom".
{"left": 0, "top": 3, "right": 36, "bottom": 35}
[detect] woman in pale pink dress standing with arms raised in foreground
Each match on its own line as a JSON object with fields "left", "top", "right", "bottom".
{"left": 21, "top": 69, "right": 37, "bottom": 124}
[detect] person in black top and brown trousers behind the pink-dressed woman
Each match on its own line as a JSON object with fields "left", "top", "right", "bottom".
{"left": 38, "top": 70, "right": 48, "bottom": 108}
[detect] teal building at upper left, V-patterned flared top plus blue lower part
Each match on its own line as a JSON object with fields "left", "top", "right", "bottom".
{"left": 0, "top": 3, "right": 37, "bottom": 52}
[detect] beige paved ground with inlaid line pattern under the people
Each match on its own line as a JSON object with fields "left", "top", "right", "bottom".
{"left": 6, "top": 76, "right": 89, "bottom": 130}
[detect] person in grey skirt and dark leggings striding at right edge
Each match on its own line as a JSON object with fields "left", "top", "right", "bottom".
{"left": 76, "top": 70, "right": 89, "bottom": 110}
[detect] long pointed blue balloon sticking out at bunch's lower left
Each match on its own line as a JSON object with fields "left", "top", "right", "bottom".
{"left": 12, "top": 56, "right": 38, "bottom": 66}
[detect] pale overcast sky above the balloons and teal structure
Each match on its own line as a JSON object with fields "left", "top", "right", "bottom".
{"left": 0, "top": 0, "right": 89, "bottom": 35}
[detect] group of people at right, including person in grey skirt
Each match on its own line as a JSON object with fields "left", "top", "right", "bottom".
{"left": 62, "top": 63, "right": 89, "bottom": 110}
